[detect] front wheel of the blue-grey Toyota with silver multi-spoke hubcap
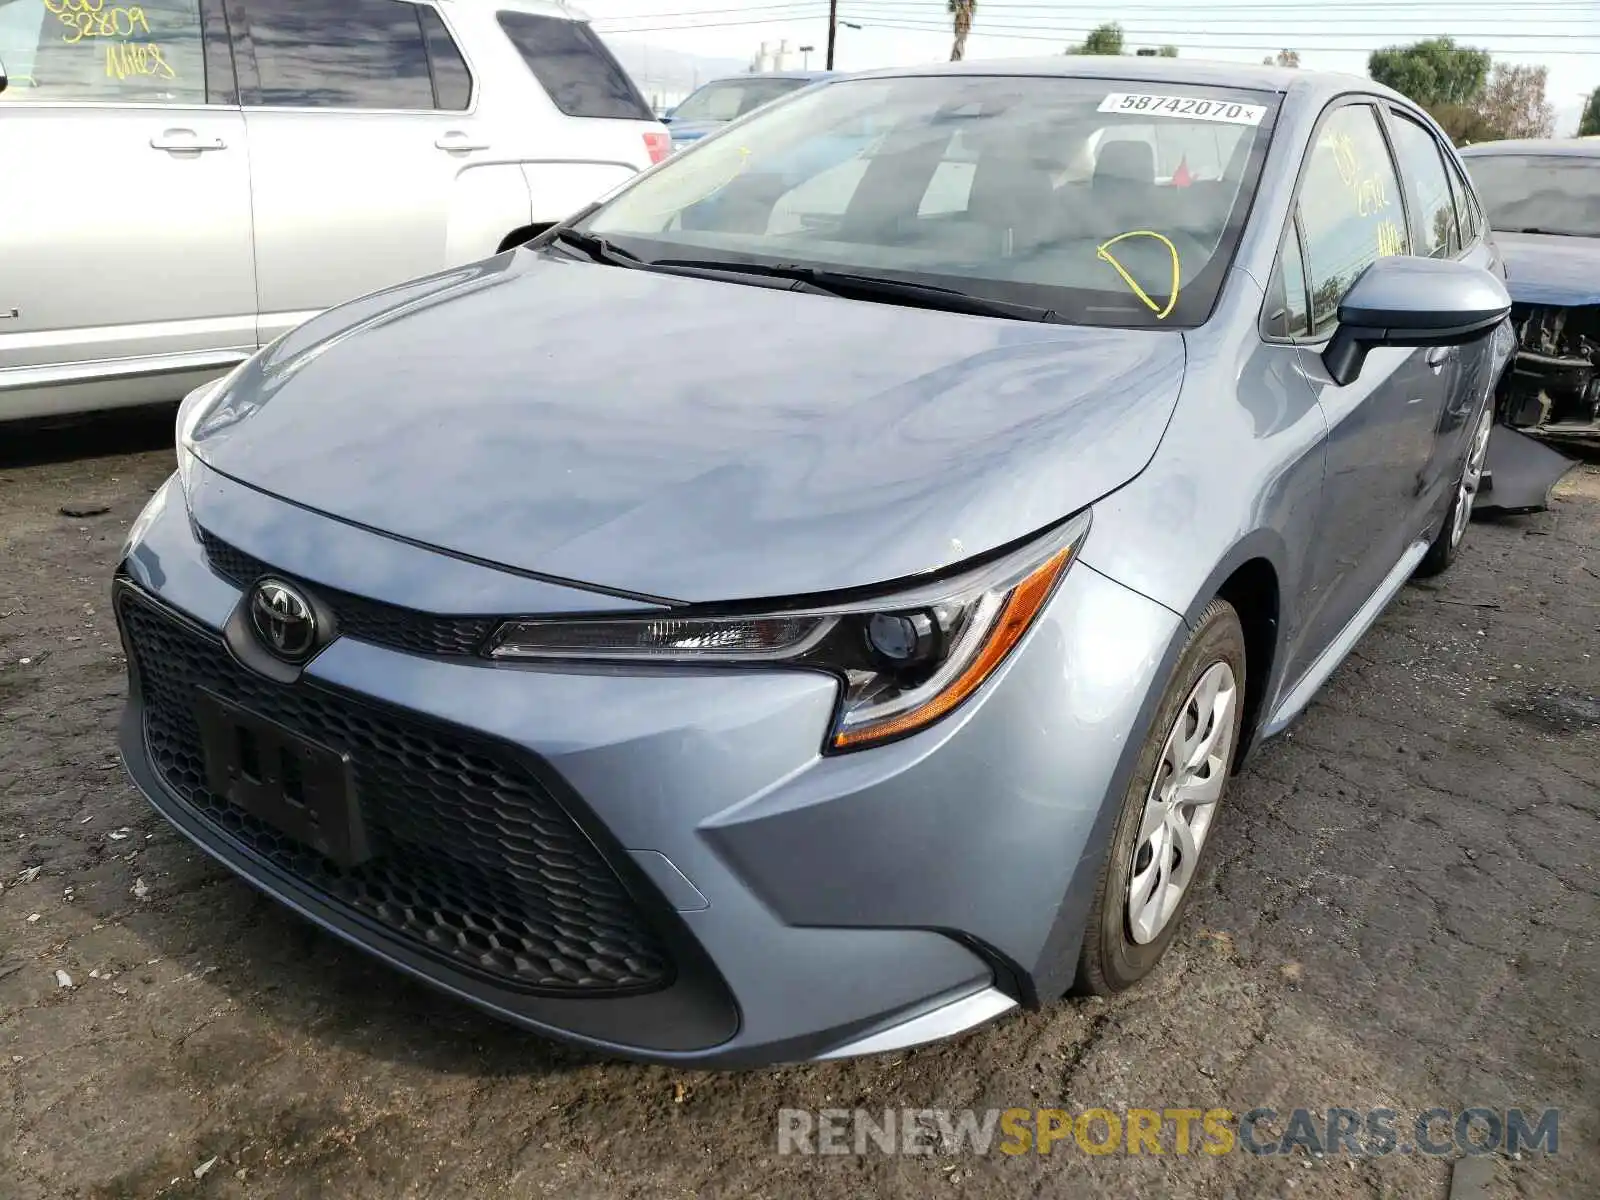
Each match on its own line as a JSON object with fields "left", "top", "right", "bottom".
{"left": 1074, "top": 600, "right": 1245, "bottom": 995}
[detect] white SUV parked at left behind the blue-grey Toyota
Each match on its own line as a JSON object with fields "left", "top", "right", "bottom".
{"left": 0, "top": 0, "right": 670, "bottom": 419}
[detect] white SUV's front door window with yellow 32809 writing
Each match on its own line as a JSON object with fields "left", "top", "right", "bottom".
{"left": 0, "top": 0, "right": 206, "bottom": 104}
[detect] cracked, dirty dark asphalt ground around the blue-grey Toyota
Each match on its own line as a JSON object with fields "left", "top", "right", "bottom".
{"left": 0, "top": 413, "right": 1600, "bottom": 1200}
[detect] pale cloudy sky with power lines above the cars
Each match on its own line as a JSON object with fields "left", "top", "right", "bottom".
{"left": 576, "top": 0, "right": 1600, "bottom": 134}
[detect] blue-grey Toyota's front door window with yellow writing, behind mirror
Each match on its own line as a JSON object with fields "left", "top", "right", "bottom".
{"left": 1299, "top": 104, "right": 1411, "bottom": 334}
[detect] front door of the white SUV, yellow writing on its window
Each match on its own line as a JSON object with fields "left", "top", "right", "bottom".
{"left": 0, "top": 0, "right": 256, "bottom": 419}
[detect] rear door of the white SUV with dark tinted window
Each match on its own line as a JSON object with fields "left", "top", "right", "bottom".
{"left": 227, "top": 0, "right": 490, "bottom": 342}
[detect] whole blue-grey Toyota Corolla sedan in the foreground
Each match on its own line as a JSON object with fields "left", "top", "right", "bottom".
{"left": 115, "top": 58, "right": 1512, "bottom": 1066}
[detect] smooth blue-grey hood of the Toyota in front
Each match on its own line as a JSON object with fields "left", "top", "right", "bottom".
{"left": 192, "top": 251, "right": 1184, "bottom": 602}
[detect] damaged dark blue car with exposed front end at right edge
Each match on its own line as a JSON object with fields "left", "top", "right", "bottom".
{"left": 1461, "top": 138, "right": 1600, "bottom": 445}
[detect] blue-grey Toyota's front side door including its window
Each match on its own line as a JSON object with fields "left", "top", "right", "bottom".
{"left": 1294, "top": 101, "right": 1448, "bottom": 662}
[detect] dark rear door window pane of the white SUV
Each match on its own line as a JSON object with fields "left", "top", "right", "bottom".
{"left": 246, "top": 0, "right": 434, "bottom": 109}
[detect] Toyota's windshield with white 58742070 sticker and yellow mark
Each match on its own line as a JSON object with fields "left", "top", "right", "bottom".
{"left": 579, "top": 75, "right": 1275, "bottom": 328}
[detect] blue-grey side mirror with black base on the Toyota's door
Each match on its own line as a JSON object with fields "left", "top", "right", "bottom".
{"left": 1322, "top": 254, "right": 1510, "bottom": 387}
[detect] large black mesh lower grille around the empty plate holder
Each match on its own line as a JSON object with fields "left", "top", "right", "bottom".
{"left": 118, "top": 589, "right": 672, "bottom": 995}
